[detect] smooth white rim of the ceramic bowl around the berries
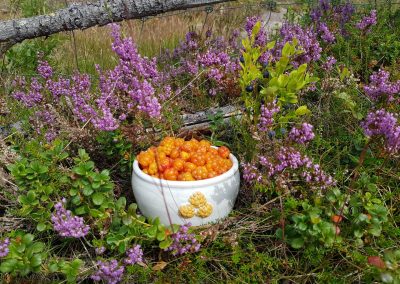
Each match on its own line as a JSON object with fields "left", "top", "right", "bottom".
{"left": 132, "top": 149, "right": 239, "bottom": 189}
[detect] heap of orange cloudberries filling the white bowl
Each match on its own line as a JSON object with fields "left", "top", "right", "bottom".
{"left": 137, "top": 137, "right": 232, "bottom": 181}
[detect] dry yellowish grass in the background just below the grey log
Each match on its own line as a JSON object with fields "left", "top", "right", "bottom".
{"left": 54, "top": 4, "right": 266, "bottom": 73}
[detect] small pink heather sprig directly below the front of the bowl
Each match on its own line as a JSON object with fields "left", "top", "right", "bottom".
{"left": 165, "top": 223, "right": 201, "bottom": 256}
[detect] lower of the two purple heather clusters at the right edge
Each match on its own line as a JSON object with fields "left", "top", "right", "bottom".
{"left": 361, "top": 109, "right": 400, "bottom": 153}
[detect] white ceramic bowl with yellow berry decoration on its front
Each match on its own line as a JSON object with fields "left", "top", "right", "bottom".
{"left": 132, "top": 151, "right": 240, "bottom": 226}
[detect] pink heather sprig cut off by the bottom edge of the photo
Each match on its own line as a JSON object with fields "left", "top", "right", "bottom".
{"left": 90, "top": 259, "right": 125, "bottom": 284}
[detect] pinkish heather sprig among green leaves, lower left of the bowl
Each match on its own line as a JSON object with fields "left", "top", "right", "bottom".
{"left": 51, "top": 198, "right": 90, "bottom": 238}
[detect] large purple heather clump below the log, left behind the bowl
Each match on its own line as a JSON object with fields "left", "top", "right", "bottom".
{"left": 12, "top": 25, "right": 172, "bottom": 141}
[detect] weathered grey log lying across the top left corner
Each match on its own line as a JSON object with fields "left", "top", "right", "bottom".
{"left": 0, "top": 0, "right": 234, "bottom": 55}
